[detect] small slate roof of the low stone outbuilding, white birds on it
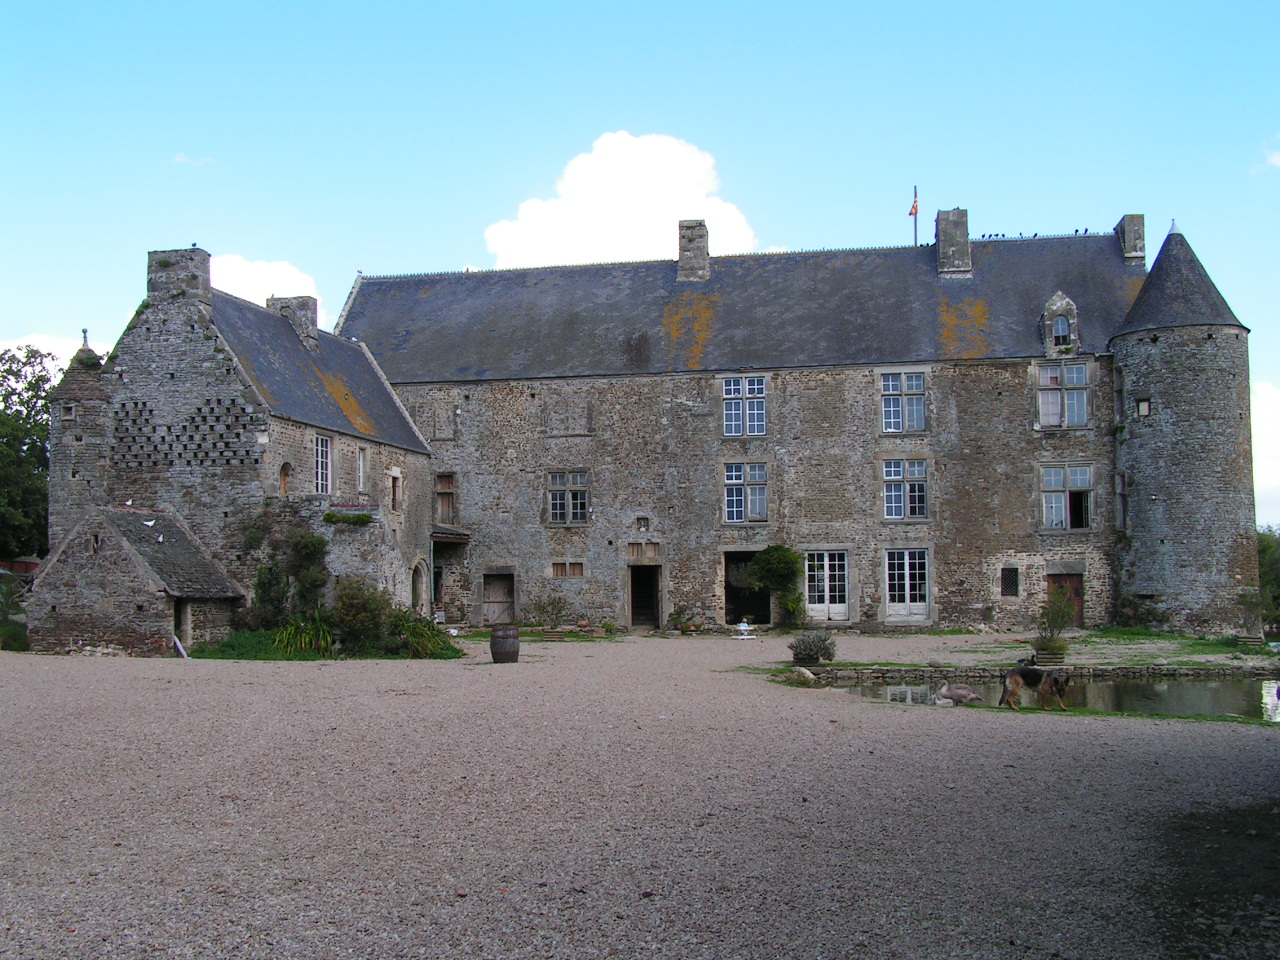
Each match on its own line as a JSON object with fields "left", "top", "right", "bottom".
{"left": 100, "top": 507, "right": 241, "bottom": 599}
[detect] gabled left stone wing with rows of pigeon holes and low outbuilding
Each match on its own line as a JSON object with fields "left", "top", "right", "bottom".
{"left": 29, "top": 250, "right": 433, "bottom": 654}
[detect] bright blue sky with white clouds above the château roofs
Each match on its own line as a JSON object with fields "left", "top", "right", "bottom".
{"left": 0, "top": 0, "right": 1280, "bottom": 524}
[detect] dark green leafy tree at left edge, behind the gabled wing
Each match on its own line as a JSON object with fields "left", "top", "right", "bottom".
{"left": 0, "top": 344, "right": 56, "bottom": 557}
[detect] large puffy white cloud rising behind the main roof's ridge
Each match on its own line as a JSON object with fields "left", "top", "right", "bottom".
{"left": 484, "top": 131, "right": 756, "bottom": 268}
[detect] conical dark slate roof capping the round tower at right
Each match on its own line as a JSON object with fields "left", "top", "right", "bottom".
{"left": 1112, "top": 224, "right": 1244, "bottom": 339}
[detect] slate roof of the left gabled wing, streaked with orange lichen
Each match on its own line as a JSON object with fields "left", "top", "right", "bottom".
{"left": 214, "top": 291, "right": 426, "bottom": 453}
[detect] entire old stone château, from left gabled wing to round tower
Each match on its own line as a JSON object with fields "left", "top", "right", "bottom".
{"left": 24, "top": 210, "right": 1257, "bottom": 652}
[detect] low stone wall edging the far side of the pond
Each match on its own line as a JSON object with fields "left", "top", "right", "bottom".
{"left": 809, "top": 663, "right": 1280, "bottom": 686}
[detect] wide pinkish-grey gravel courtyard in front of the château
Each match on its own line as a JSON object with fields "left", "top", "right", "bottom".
{"left": 0, "top": 637, "right": 1280, "bottom": 960}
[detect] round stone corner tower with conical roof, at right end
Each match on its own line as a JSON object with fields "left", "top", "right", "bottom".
{"left": 1111, "top": 225, "right": 1258, "bottom": 632}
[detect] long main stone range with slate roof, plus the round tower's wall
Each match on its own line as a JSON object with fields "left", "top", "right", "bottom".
{"left": 340, "top": 210, "right": 1257, "bottom": 632}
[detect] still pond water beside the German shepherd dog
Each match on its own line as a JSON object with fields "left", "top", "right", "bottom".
{"left": 842, "top": 680, "right": 1280, "bottom": 723}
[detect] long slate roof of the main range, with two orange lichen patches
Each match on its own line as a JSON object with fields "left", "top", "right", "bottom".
{"left": 339, "top": 234, "right": 1146, "bottom": 383}
